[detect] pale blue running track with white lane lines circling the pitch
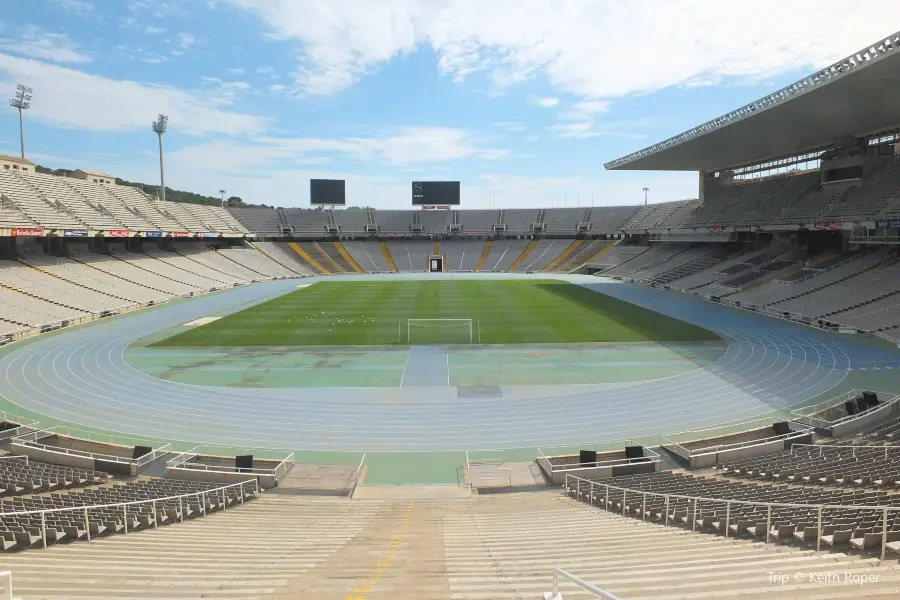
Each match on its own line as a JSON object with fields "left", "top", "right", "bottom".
{"left": 0, "top": 277, "right": 900, "bottom": 451}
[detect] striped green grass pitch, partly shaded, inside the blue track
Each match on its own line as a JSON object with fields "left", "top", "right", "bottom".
{"left": 153, "top": 279, "right": 719, "bottom": 347}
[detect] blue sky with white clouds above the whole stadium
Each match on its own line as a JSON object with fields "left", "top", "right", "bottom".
{"left": 0, "top": 0, "right": 900, "bottom": 208}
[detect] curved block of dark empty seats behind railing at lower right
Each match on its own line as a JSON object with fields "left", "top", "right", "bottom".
{"left": 566, "top": 472, "right": 900, "bottom": 553}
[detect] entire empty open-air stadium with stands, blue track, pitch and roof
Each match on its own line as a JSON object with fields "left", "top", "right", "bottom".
{"left": 0, "top": 25, "right": 900, "bottom": 600}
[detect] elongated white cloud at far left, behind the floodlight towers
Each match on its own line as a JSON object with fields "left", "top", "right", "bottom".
{"left": 0, "top": 54, "right": 266, "bottom": 134}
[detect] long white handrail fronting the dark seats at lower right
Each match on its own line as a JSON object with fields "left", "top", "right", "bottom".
{"left": 564, "top": 473, "right": 900, "bottom": 560}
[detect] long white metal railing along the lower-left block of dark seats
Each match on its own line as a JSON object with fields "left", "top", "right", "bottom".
{"left": 0, "top": 479, "right": 260, "bottom": 548}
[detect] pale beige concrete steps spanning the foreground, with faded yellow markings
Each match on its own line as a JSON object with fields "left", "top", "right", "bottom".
{"left": 8, "top": 490, "right": 900, "bottom": 600}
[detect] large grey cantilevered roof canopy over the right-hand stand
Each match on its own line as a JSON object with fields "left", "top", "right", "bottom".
{"left": 605, "top": 32, "right": 900, "bottom": 171}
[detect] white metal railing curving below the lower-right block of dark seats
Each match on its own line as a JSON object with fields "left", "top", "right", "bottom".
{"left": 564, "top": 473, "right": 900, "bottom": 560}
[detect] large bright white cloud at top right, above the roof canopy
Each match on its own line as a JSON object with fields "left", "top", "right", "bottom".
{"left": 227, "top": 0, "right": 900, "bottom": 99}
